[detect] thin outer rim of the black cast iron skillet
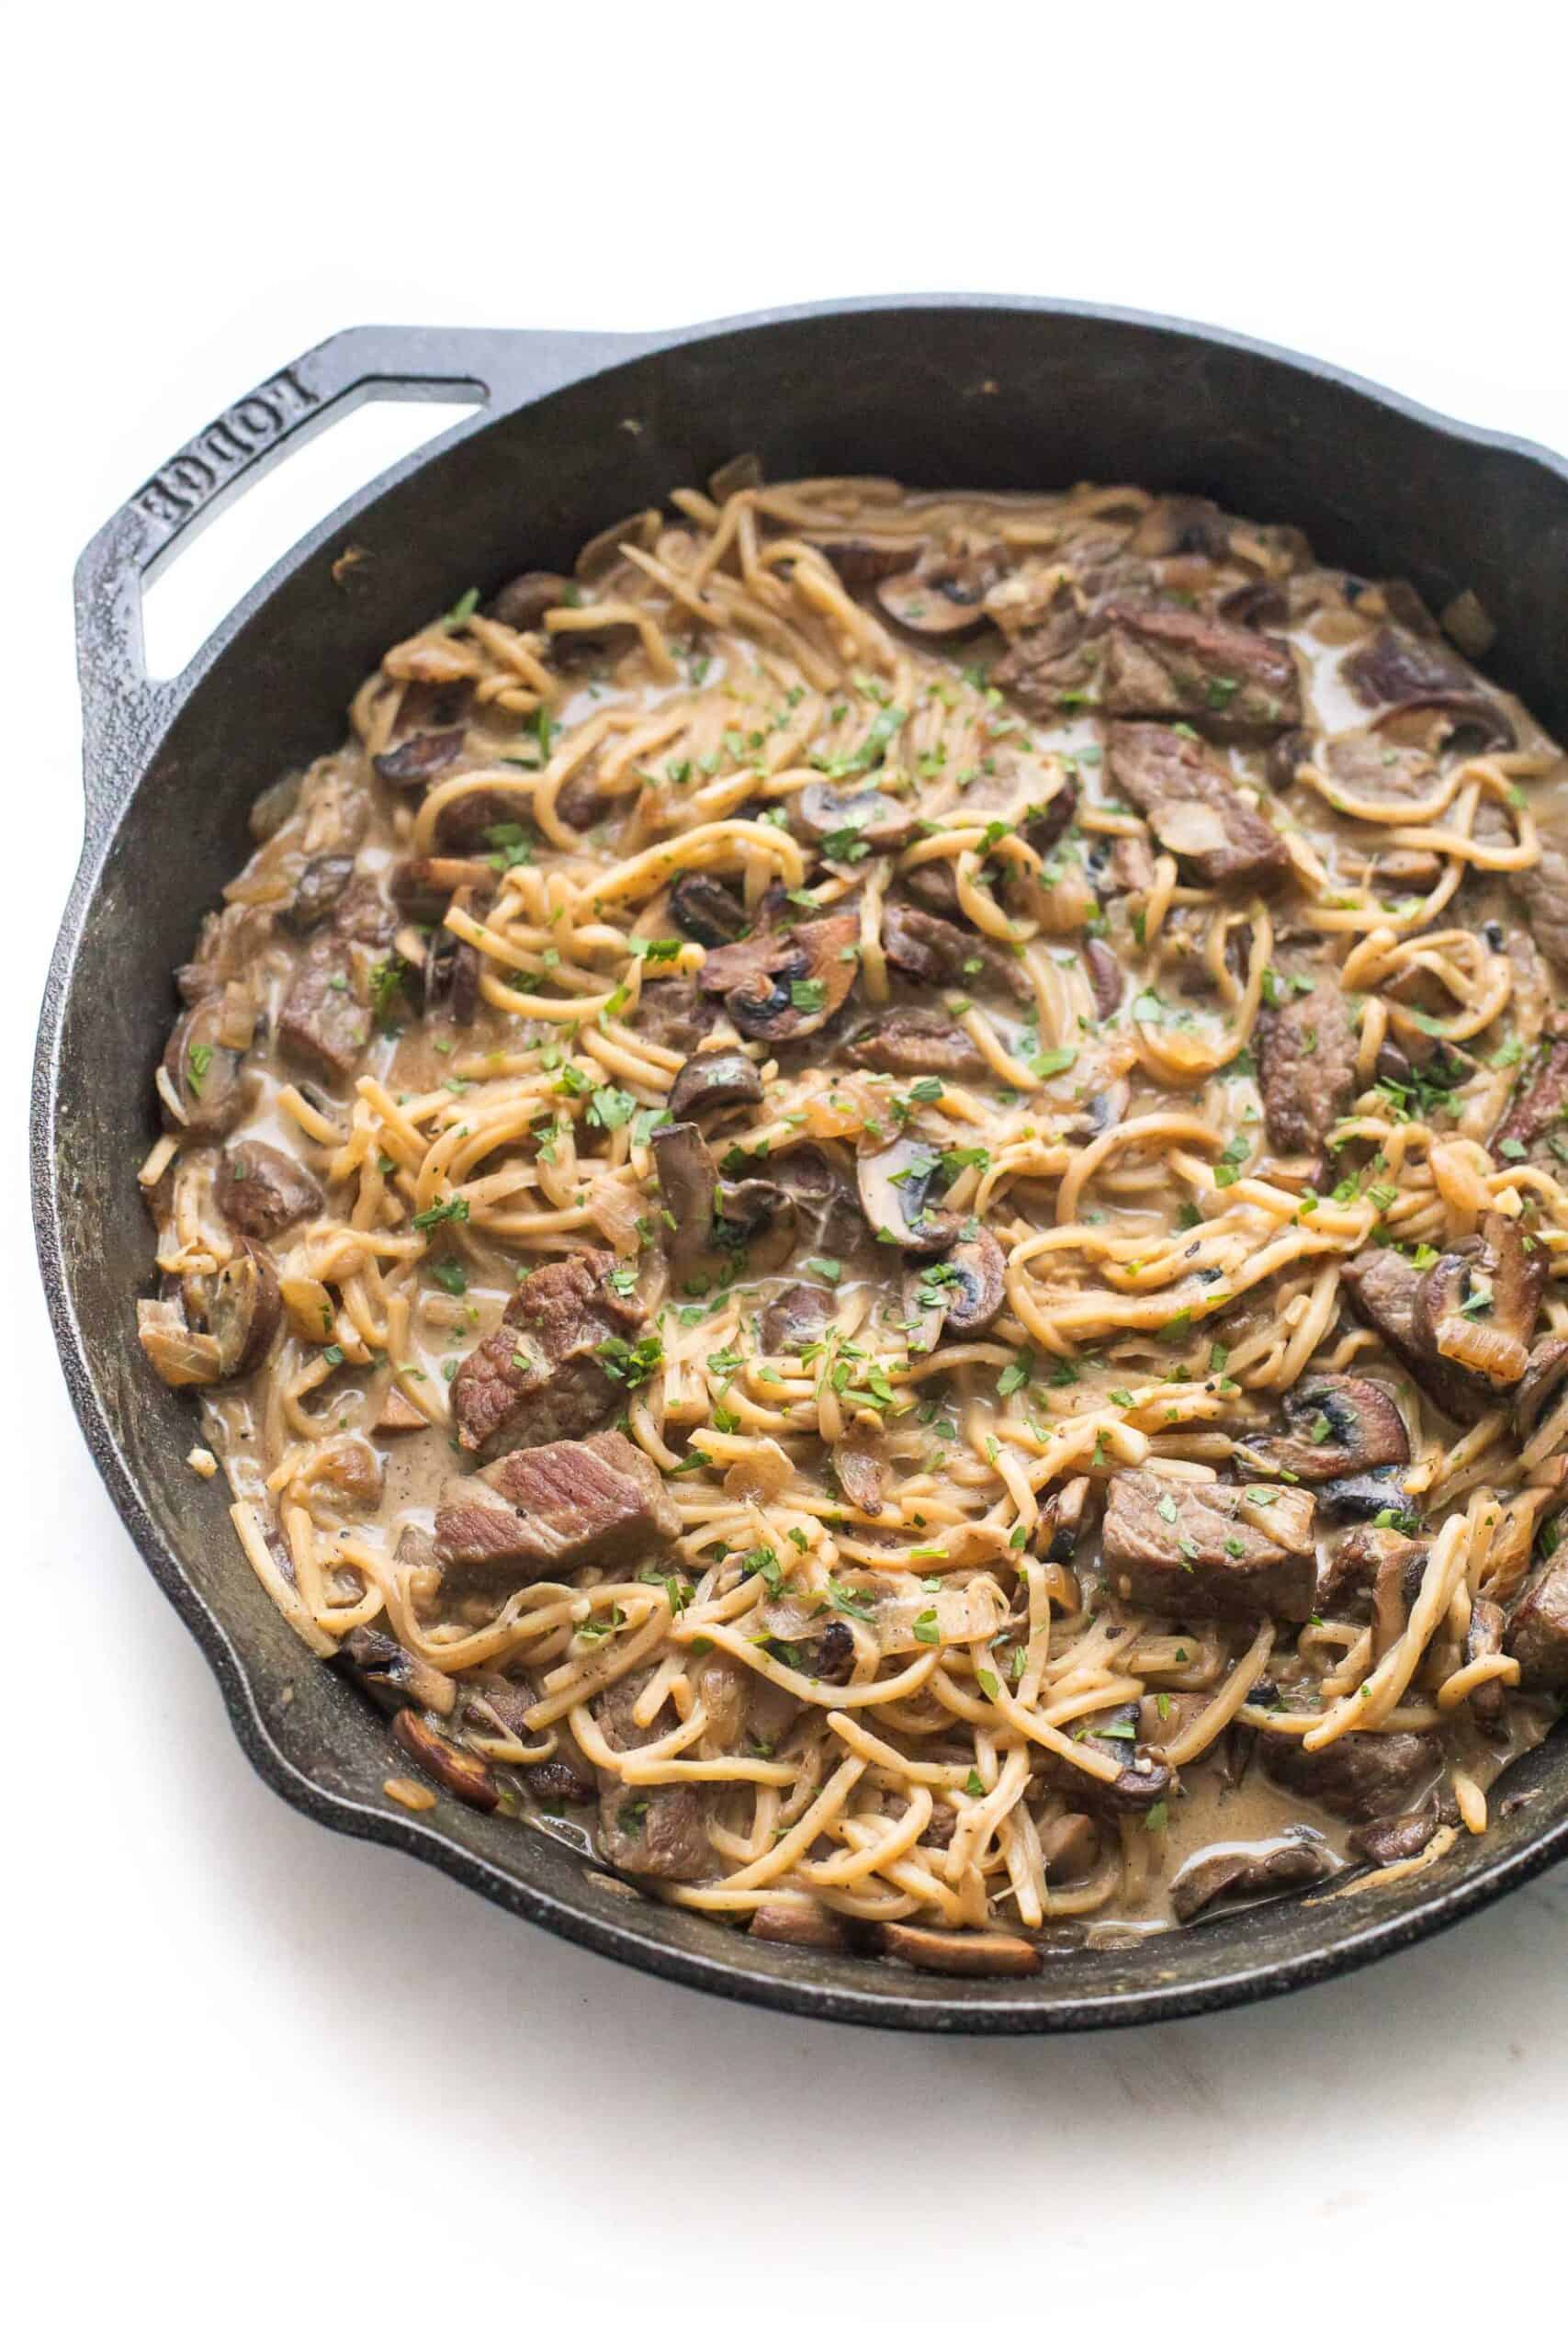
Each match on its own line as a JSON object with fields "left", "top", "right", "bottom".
{"left": 30, "top": 294, "right": 1568, "bottom": 2034}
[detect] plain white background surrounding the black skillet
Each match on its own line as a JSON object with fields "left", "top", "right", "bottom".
{"left": 0, "top": 0, "right": 1568, "bottom": 2347}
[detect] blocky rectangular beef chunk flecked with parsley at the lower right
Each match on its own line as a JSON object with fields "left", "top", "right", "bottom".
{"left": 1102, "top": 1470, "right": 1316, "bottom": 1625}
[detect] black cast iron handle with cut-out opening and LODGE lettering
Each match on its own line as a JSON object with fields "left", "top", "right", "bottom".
{"left": 75, "top": 327, "right": 644, "bottom": 849}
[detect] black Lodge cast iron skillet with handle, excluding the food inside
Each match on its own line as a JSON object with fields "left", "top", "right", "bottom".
{"left": 33, "top": 297, "right": 1568, "bottom": 2032}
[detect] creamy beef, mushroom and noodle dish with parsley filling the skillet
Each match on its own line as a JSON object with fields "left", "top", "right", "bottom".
{"left": 139, "top": 461, "right": 1568, "bottom": 1973}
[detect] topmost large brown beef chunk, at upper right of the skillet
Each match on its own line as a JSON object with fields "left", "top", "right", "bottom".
{"left": 1100, "top": 605, "right": 1303, "bottom": 731}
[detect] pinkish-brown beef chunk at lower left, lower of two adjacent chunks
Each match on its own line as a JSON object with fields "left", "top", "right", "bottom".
{"left": 434, "top": 1430, "right": 680, "bottom": 1597}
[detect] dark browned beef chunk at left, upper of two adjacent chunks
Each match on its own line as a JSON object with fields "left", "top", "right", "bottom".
{"left": 451, "top": 1249, "right": 644, "bottom": 1461}
